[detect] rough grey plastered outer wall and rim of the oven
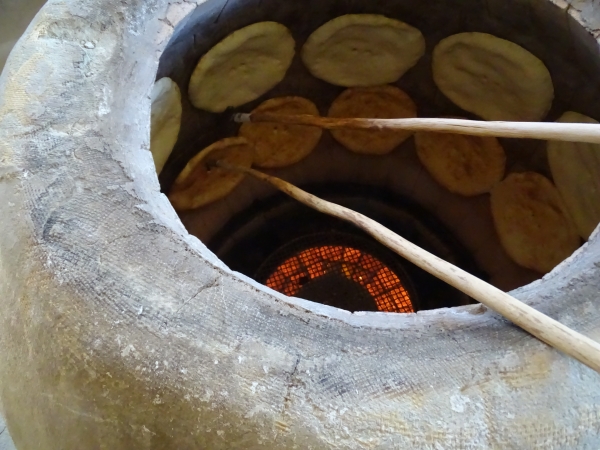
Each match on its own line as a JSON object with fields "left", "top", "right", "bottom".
{"left": 0, "top": 0, "right": 600, "bottom": 450}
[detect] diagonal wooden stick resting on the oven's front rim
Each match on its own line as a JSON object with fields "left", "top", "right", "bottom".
{"left": 216, "top": 161, "right": 600, "bottom": 373}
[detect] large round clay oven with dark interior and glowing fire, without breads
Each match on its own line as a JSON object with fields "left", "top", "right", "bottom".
{"left": 0, "top": 0, "right": 600, "bottom": 449}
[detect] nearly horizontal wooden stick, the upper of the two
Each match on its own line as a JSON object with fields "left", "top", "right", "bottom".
{"left": 233, "top": 113, "right": 600, "bottom": 144}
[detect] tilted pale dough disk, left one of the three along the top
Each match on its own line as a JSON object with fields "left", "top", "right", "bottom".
{"left": 189, "top": 22, "right": 295, "bottom": 112}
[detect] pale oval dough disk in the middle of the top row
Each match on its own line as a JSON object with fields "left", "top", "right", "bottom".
{"left": 302, "top": 14, "right": 425, "bottom": 87}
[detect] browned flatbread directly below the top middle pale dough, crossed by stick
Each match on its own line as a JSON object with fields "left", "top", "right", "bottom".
{"left": 328, "top": 86, "right": 417, "bottom": 155}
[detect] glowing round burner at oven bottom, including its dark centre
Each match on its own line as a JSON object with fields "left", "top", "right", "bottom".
{"left": 265, "top": 245, "right": 414, "bottom": 313}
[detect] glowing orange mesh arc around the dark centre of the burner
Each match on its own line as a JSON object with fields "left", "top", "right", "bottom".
{"left": 255, "top": 236, "right": 414, "bottom": 313}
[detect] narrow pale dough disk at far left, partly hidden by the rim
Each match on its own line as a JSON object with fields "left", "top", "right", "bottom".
{"left": 150, "top": 77, "right": 181, "bottom": 174}
